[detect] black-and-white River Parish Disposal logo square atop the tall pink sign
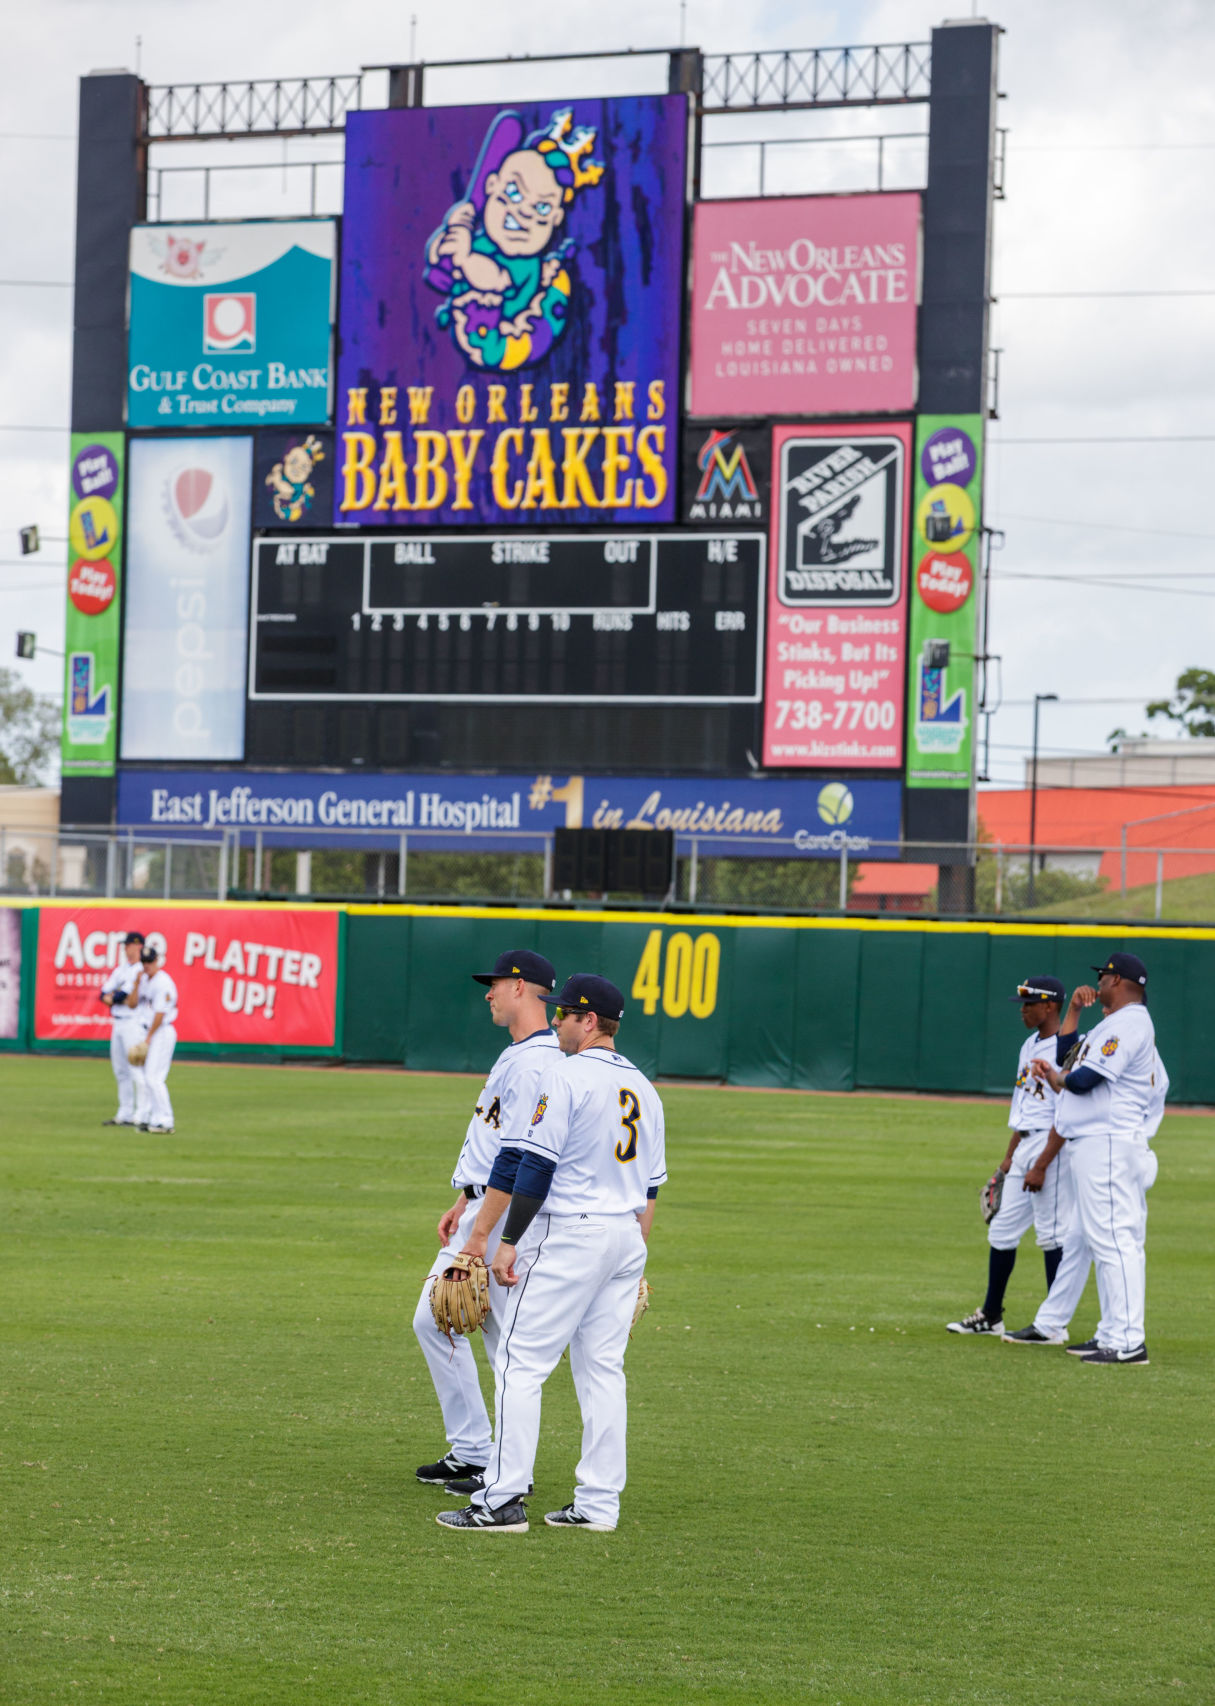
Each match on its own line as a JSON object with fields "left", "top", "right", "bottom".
{"left": 778, "top": 435, "right": 906, "bottom": 607}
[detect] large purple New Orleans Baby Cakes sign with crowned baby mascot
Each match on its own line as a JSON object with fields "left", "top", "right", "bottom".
{"left": 334, "top": 96, "right": 686, "bottom": 527}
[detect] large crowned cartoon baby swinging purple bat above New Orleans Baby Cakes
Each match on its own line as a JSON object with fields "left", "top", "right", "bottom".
{"left": 425, "top": 107, "right": 604, "bottom": 374}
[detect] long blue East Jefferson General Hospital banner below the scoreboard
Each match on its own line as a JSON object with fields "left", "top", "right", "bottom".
{"left": 118, "top": 769, "right": 901, "bottom": 858}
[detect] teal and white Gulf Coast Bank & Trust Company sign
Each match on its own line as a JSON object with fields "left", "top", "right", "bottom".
{"left": 126, "top": 218, "right": 336, "bottom": 427}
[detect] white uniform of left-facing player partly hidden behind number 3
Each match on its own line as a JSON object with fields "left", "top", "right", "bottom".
{"left": 413, "top": 1025, "right": 560, "bottom": 1464}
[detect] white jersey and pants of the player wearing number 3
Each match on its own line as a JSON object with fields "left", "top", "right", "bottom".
{"left": 473, "top": 1047, "right": 667, "bottom": 1529}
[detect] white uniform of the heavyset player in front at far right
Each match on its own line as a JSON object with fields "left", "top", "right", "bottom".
{"left": 1034, "top": 1003, "right": 1169, "bottom": 1351}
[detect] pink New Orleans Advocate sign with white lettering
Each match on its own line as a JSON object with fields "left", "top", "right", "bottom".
{"left": 691, "top": 193, "right": 920, "bottom": 416}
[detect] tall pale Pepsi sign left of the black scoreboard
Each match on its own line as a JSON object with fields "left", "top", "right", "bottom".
{"left": 121, "top": 437, "right": 253, "bottom": 761}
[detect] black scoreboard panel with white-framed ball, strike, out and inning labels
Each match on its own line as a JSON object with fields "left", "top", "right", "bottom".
{"left": 249, "top": 532, "right": 766, "bottom": 705}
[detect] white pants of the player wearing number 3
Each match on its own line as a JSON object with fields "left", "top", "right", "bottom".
{"left": 473, "top": 1215, "right": 645, "bottom": 1529}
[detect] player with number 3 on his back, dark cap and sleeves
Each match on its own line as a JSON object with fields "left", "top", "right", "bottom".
{"left": 437, "top": 972, "right": 667, "bottom": 1534}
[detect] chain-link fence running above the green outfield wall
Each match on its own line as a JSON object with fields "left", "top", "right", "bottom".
{"left": 0, "top": 826, "right": 1215, "bottom": 923}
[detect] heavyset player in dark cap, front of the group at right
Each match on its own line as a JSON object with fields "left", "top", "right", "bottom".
{"left": 1007, "top": 954, "right": 1169, "bottom": 1367}
